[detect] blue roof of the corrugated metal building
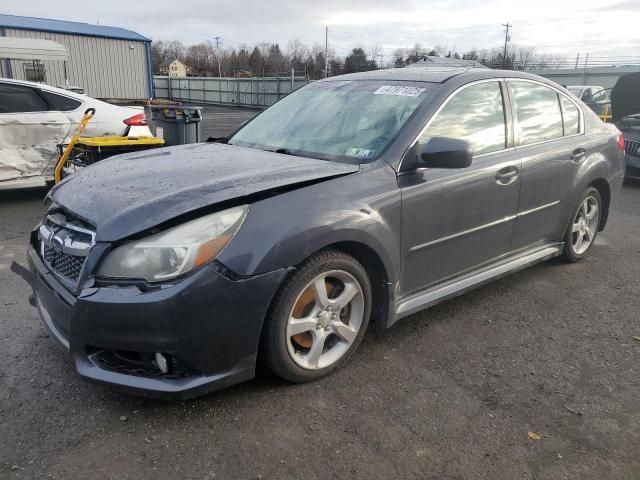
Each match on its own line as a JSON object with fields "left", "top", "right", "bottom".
{"left": 0, "top": 14, "right": 151, "bottom": 42}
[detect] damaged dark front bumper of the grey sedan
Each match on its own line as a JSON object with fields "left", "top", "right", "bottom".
{"left": 28, "top": 246, "right": 286, "bottom": 398}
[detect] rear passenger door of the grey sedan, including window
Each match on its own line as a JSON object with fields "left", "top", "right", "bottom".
{"left": 507, "top": 80, "right": 590, "bottom": 249}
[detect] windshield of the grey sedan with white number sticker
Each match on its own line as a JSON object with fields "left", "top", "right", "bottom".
{"left": 229, "top": 81, "right": 433, "bottom": 163}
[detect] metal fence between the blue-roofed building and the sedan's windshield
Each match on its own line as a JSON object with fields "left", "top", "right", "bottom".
{"left": 153, "top": 77, "right": 309, "bottom": 108}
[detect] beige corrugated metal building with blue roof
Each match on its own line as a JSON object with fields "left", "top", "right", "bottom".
{"left": 0, "top": 14, "right": 153, "bottom": 100}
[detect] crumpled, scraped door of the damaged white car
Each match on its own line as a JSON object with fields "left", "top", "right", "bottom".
{"left": 0, "top": 82, "right": 70, "bottom": 182}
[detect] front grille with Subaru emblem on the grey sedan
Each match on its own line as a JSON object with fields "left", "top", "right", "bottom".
{"left": 39, "top": 212, "right": 95, "bottom": 288}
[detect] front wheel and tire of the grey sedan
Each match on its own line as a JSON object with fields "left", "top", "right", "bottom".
{"left": 260, "top": 250, "right": 371, "bottom": 383}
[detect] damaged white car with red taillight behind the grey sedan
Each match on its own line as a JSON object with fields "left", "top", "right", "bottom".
{"left": 0, "top": 78, "right": 152, "bottom": 190}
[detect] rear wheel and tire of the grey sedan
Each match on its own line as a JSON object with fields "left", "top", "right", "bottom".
{"left": 562, "top": 187, "right": 602, "bottom": 263}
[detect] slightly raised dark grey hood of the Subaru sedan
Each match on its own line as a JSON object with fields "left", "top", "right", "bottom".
{"left": 50, "top": 143, "right": 360, "bottom": 241}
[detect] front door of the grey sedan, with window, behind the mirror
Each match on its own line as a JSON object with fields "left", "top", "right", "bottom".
{"left": 398, "top": 80, "right": 520, "bottom": 295}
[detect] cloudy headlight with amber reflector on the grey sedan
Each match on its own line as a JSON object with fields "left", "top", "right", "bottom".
{"left": 97, "top": 205, "right": 248, "bottom": 282}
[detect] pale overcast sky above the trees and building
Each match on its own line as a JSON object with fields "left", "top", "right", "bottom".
{"left": 0, "top": 0, "right": 640, "bottom": 63}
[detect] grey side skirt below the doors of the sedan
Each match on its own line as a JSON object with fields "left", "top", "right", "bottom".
{"left": 389, "top": 243, "right": 564, "bottom": 326}
